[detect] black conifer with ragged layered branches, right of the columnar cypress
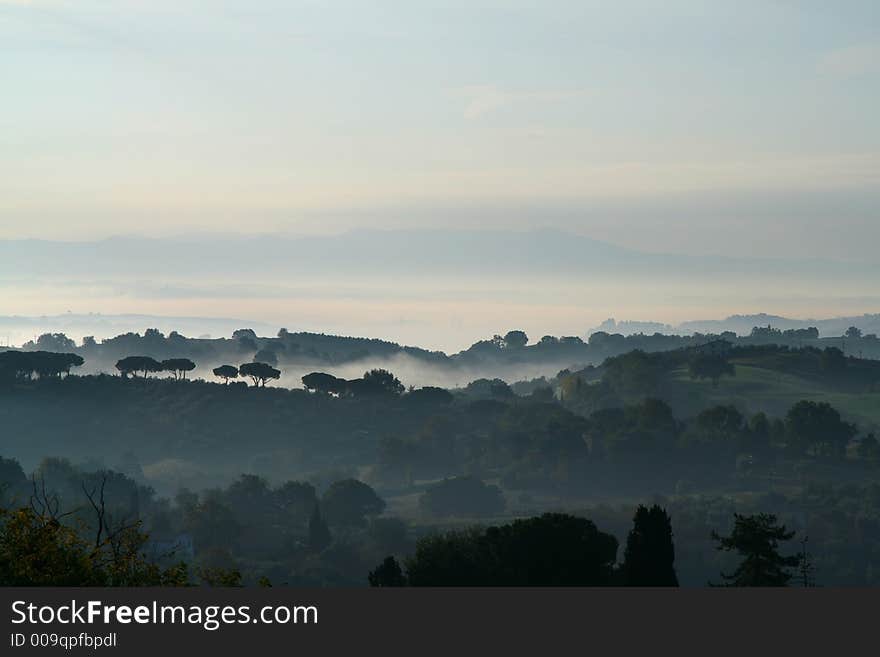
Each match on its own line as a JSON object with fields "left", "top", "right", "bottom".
{"left": 712, "top": 513, "right": 801, "bottom": 586}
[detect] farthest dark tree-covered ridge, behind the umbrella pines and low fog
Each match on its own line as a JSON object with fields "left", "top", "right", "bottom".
{"left": 22, "top": 320, "right": 880, "bottom": 382}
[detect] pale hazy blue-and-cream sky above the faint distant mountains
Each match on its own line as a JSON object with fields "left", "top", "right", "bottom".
{"left": 0, "top": 0, "right": 880, "bottom": 260}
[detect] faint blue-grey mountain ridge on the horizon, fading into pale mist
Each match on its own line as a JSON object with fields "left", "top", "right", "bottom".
{"left": 0, "top": 229, "right": 880, "bottom": 278}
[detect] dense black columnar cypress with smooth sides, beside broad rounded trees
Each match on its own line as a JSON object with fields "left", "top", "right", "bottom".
{"left": 621, "top": 504, "right": 678, "bottom": 586}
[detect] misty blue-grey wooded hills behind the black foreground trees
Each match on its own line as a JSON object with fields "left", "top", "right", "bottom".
{"left": 0, "top": 331, "right": 880, "bottom": 585}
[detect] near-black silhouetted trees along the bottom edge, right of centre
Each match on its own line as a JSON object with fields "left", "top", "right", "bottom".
{"left": 368, "top": 504, "right": 815, "bottom": 587}
